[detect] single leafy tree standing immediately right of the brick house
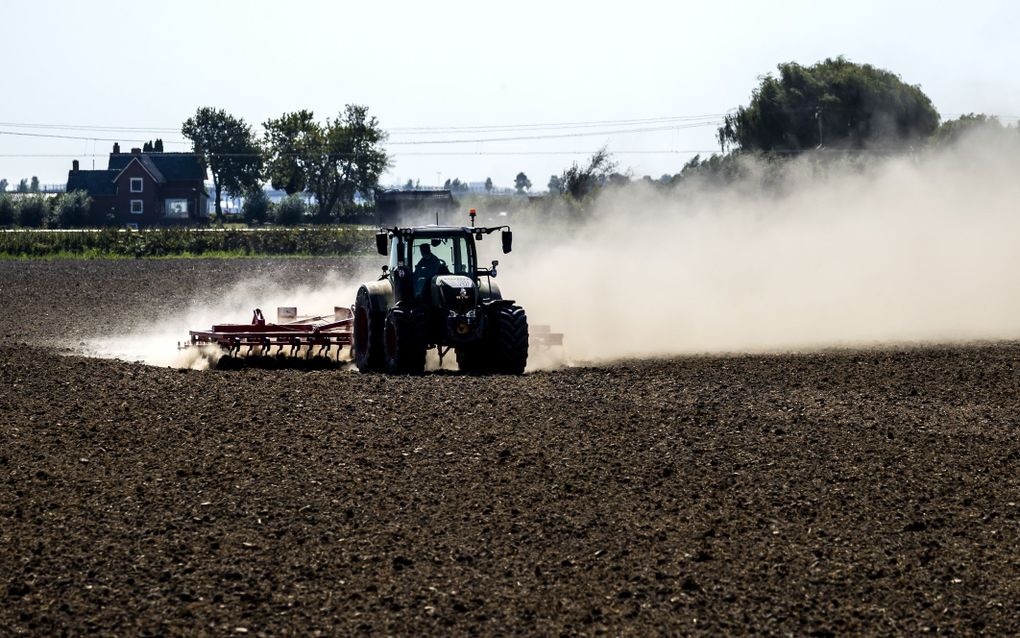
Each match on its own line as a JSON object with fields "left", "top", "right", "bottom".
{"left": 181, "top": 106, "right": 262, "bottom": 219}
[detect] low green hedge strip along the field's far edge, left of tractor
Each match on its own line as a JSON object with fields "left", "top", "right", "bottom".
{"left": 0, "top": 226, "right": 373, "bottom": 259}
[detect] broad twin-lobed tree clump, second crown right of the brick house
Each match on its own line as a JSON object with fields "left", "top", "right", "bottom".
{"left": 264, "top": 104, "right": 389, "bottom": 219}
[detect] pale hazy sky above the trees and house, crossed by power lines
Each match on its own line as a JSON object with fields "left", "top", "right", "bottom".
{"left": 0, "top": 0, "right": 1020, "bottom": 189}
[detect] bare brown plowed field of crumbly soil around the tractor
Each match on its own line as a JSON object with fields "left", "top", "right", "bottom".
{"left": 0, "top": 260, "right": 1020, "bottom": 636}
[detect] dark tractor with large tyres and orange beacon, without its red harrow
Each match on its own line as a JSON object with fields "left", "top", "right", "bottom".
{"left": 352, "top": 208, "right": 528, "bottom": 375}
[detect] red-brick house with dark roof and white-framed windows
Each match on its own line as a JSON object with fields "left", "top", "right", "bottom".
{"left": 67, "top": 144, "right": 209, "bottom": 227}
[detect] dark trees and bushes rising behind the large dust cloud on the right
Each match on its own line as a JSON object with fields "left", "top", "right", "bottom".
{"left": 549, "top": 57, "right": 1020, "bottom": 202}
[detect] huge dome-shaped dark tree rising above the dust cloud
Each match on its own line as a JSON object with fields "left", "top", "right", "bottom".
{"left": 718, "top": 57, "right": 938, "bottom": 152}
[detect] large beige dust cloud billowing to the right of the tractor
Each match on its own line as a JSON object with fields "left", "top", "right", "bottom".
{"left": 500, "top": 131, "right": 1020, "bottom": 361}
